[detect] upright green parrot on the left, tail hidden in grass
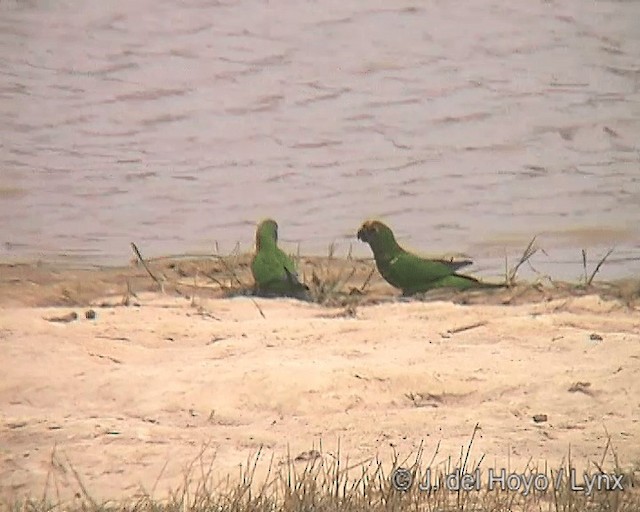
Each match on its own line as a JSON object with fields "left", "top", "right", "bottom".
{"left": 251, "top": 219, "right": 309, "bottom": 297}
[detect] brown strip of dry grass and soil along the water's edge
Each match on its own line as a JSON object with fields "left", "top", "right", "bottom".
{"left": 0, "top": 237, "right": 640, "bottom": 310}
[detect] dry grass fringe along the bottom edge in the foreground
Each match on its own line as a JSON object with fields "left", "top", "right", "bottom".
{"left": 4, "top": 425, "right": 640, "bottom": 512}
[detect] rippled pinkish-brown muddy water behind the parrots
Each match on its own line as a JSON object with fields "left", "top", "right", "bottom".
{"left": 0, "top": 0, "right": 640, "bottom": 278}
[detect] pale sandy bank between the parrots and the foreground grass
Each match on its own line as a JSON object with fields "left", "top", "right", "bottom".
{"left": 0, "top": 256, "right": 640, "bottom": 500}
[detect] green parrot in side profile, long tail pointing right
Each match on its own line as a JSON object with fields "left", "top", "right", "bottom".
{"left": 358, "top": 220, "right": 503, "bottom": 295}
